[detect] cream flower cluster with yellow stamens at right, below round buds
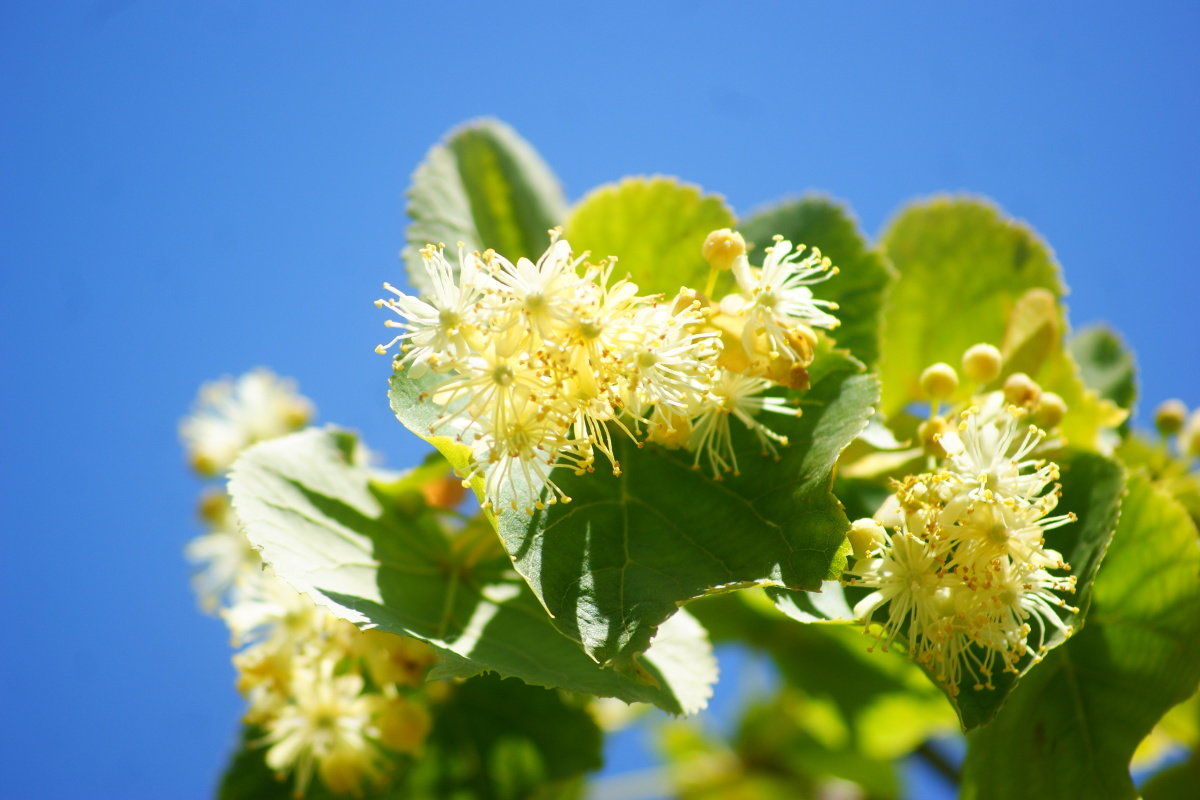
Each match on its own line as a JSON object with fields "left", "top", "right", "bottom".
{"left": 847, "top": 348, "right": 1076, "bottom": 693}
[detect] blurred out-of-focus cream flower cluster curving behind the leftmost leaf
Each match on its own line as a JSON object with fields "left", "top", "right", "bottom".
{"left": 181, "top": 369, "right": 440, "bottom": 796}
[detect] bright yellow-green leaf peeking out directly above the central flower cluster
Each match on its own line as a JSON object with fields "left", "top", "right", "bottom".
{"left": 565, "top": 178, "right": 733, "bottom": 296}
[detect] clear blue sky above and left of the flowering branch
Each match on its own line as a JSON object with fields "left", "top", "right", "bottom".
{"left": 0, "top": 0, "right": 1200, "bottom": 800}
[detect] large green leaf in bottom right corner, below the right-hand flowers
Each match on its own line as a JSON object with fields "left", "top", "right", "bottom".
{"left": 964, "top": 475, "right": 1200, "bottom": 800}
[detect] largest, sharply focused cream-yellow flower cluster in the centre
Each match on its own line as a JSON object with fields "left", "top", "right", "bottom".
{"left": 376, "top": 230, "right": 836, "bottom": 511}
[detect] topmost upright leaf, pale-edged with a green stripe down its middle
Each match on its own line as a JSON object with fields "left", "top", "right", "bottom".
{"left": 404, "top": 119, "right": 566, "bottom": 291}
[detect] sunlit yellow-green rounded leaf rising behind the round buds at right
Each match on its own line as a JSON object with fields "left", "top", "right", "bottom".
{"left": 880, "top": 197, "right": 1064, "bottom": 416}
